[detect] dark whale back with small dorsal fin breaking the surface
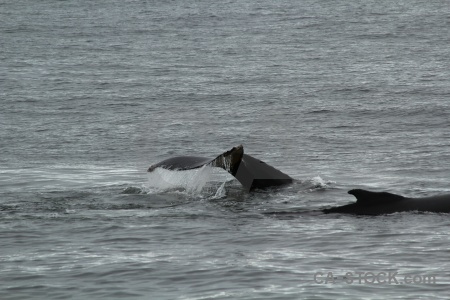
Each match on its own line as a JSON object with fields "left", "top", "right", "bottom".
{"left": 323, "top": 189, "right": 450, "bottom": 216}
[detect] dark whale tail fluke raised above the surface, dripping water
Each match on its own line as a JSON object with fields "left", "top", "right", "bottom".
{"left": 148, "top": 145, "right": 294, "bottom": 191}
